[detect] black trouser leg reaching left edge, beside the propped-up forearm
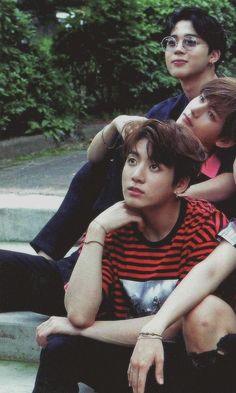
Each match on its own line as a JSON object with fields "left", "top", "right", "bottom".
{"left": 0, "top": 250, "right": 78, "bottom": 315}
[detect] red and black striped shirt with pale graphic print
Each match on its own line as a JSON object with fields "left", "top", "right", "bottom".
{"left": 102, "top": 198, "right": 228, "bottom": 319}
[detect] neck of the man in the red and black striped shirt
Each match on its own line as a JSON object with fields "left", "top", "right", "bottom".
{"left": 142, "top": 198, "right": 180, "bottom": 241}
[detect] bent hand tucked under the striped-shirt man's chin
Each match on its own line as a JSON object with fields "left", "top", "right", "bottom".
{"left": 93, "top": 201, "right": 144, "bottom": 232}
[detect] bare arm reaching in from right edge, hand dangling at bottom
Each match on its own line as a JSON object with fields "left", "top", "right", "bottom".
{"left": 129, "top": 241, "right": 236, "bottom": 393}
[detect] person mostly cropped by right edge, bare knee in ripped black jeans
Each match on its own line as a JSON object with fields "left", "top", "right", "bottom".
{"left": 129, "top": 224, "right": 236, "bottom": 393}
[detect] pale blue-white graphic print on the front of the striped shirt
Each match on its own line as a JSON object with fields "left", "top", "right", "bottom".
{"left": 120, "top": 279, "right": 178, "bottom": 318}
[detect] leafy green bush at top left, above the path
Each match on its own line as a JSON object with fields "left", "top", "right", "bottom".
{"left": 0, "top": 0, "right": 83, "bottom": 140}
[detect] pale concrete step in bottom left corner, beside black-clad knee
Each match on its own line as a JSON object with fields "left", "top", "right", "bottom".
{"left": 0, "top": 311, "right": 94, "bottom": 393}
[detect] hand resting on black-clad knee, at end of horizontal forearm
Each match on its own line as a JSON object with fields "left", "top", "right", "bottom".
{"left": 36, "top": 317, "right": 80, "bottom": 347}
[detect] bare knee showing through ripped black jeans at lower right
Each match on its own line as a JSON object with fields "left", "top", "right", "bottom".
{"left": 183, "top": 295, "right": 236, "bottom": 353}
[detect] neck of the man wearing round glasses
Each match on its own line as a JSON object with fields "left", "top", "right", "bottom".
{"left": 180, "top": 69, "right": 217, "bottom": 100}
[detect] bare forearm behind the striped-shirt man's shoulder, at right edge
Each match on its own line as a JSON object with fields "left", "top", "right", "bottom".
{"left": 183, "top": 172, "right": 236, "bottom": 202}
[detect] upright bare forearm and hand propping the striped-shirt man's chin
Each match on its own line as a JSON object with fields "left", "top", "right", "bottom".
{"left": 65, "top": 201, "right": 143, "bottom": 328}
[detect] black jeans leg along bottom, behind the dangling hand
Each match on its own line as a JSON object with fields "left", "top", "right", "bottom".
{"left": 33, "top": 335, "right": 190, "bottom": 393}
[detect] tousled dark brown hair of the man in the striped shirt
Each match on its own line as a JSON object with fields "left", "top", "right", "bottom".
{"left": 124, "top": 119, "right": 207, "bottom": 184}
